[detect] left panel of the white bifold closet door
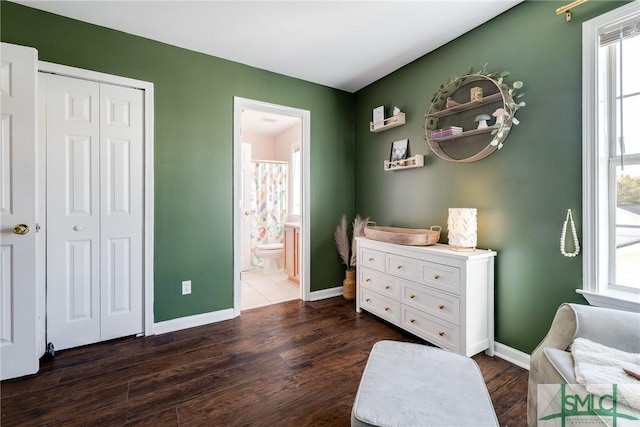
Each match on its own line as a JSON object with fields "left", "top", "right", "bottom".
{"left": 45, "top": 75, "right": 100, "bottom": 349}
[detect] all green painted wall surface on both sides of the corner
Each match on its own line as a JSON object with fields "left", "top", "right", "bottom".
{"left": 0, "top": 1, "right": 626, "bottom": 353}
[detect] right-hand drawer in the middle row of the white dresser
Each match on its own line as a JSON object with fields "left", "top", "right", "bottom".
{"left": 402, "top": 283, "right": 460, "bottom": 325}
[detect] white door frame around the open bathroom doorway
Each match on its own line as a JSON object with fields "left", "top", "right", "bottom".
{"left": 233, "top": 96, "right": 311, "bottom": 316}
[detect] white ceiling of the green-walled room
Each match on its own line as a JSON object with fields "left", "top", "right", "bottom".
{"left": 14, "top": 0, "right": 522, "bottom": 92}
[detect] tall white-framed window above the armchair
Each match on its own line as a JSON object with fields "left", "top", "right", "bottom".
{"left": 581, "top": 0, "right": 640, "bottom": 310}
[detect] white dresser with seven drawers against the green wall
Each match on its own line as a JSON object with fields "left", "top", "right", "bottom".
{"left": 356, "top": 237, "right": 496, "bottom": 356}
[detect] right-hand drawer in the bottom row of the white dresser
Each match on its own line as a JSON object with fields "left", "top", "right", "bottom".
{"left": 402, "top": 306, "right": 460, "bottom": 352}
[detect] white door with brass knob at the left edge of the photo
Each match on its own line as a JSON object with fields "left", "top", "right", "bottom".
{"left": 0, "top": 43, "right": 39, "bottom": 380}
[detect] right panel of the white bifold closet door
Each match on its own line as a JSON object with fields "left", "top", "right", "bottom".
{"left": 100, "top": 84, "right": 143, "bottom": 340}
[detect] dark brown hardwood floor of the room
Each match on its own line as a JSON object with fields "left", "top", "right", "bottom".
{"left": 0, "top": 297, "right": 528, "bottom": 427}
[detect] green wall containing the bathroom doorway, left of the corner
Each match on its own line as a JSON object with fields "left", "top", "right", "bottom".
{"left": 0, "top": 1, "right": 354, "bottom": 322}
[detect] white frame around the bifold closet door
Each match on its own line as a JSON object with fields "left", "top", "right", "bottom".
{"left": 36, "top": 61, "right": 154, "bottom": 335}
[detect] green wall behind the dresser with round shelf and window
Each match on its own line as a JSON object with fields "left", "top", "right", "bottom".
{"left": 355, "top": 1, "right": 625, "bottom": 353}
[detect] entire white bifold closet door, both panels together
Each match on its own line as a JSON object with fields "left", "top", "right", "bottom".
{"left": 45, "top": 75, "right": 144, "bottom": 349}
